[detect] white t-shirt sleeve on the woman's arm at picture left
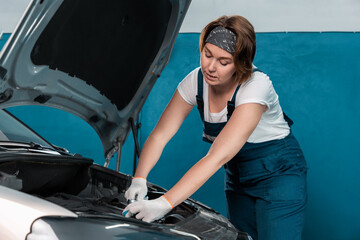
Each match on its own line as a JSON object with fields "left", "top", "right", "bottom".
{"left": 177, "top": 68, "right": 200, "bottom": 105}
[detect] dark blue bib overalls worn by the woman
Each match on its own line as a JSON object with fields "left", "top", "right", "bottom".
{"left": 196, "top": 69, "right": 307, "bottom": 240}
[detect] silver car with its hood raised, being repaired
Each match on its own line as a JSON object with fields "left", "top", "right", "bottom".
{"left": 0, "top": 0, "right": 251, "bottom": 240}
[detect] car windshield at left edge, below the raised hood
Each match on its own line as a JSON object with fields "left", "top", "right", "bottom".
{"left": 0, "top": 110, "right": 53, "bottom": 148}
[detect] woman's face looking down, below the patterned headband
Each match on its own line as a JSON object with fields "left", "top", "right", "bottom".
{"left": 201, "top": 43, "right": 235, "bottom": 86}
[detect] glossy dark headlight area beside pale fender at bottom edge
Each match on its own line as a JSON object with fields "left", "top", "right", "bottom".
{"left": 29, "top": 217, "right": 200, "bottom": 240}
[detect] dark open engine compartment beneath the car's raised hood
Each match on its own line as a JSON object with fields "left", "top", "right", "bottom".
{"left": 0, "top": 153, "right": 197, "bottom": 224}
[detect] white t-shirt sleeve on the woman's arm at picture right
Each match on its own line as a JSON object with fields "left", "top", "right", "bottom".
{"left": 235, "top": 72, "right": 276, "bottom": 110}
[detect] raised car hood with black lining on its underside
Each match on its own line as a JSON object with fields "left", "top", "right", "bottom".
{"left": 0, "top": 0, "right": 190, "bottom": 158}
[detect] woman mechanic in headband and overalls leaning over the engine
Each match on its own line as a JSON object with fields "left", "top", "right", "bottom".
{"left": 124, "top": 16, "right": 307, "bottom": 240}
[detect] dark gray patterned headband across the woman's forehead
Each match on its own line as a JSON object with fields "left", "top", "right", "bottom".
{"left": 205, "top": 26, "right": 236, "bottom": 55}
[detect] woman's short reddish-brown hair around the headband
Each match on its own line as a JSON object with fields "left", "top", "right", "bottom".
{"left": 200, "top": 15, "right": 256, "bottom": 83}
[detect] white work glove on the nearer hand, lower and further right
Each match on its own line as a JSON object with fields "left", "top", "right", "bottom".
{"left": 123, "top": 196, "right": 173, "bottom": 222}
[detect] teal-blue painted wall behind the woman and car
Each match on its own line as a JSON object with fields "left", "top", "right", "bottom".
{"left": 0, "top": 33, "right": 360, "bottom": 240}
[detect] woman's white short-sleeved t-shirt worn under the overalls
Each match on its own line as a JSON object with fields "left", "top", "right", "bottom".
{"left": 177, "top": 67, "right": 290, "bottom": 143}
